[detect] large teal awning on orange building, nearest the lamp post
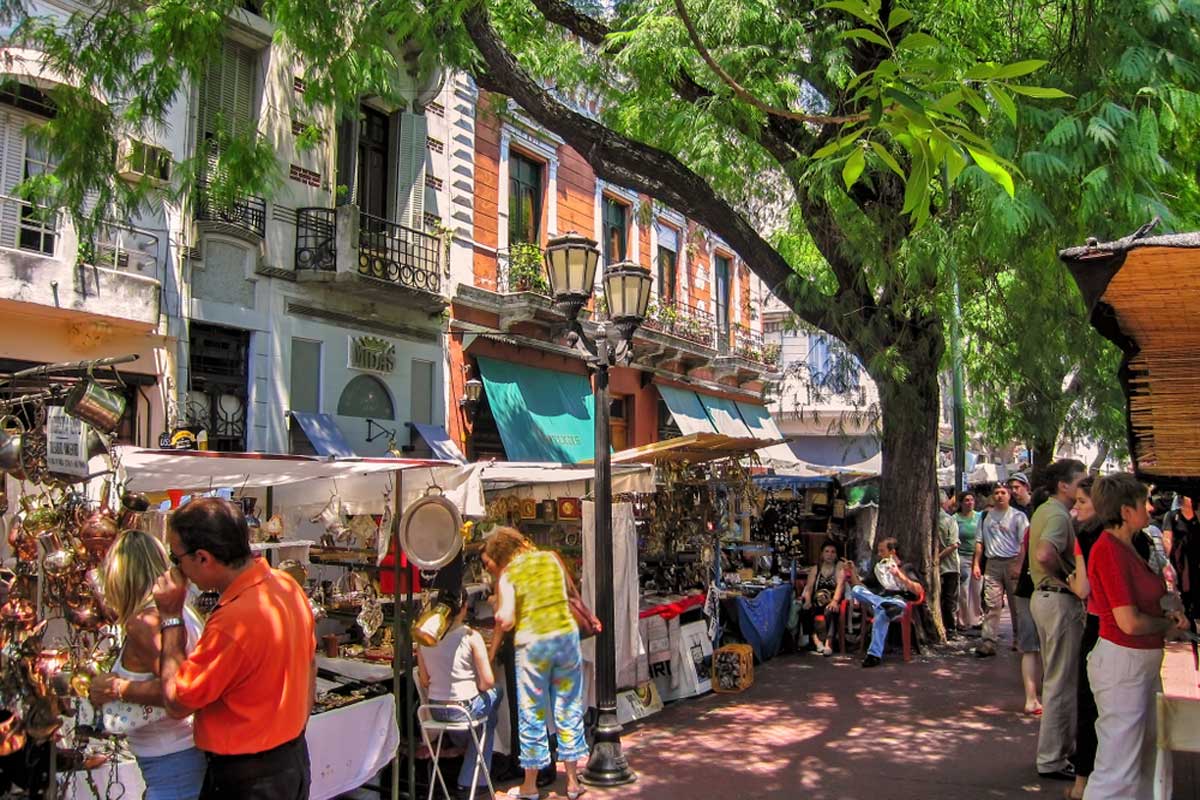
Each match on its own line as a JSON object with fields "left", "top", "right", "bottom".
{"left": 476, "top": 356, "right": 595, "bottom": 464}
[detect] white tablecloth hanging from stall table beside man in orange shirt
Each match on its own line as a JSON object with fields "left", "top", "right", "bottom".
{"left": 66, "top": 694, "right": 400, "bottom": 800}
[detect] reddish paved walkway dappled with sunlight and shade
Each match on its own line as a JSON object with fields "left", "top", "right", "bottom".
{"left": 535, "top": 639, "right": 1200, "bottom": 800}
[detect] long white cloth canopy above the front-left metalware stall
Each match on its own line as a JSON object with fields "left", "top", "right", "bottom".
{"left": 116, "top": 447, "right": 485, "bottom": 516}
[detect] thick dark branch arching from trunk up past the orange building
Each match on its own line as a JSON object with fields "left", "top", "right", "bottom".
{"left": 463, "top": 4, "right": 834, "bottom": 330}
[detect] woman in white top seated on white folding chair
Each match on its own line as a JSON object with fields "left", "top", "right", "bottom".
{"left": 416, "top": 589, "right": 500, "bottom": 796}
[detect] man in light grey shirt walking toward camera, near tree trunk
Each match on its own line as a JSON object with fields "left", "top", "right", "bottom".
{"left": 972, "top": 483, "right": 1030, "bottom": 658}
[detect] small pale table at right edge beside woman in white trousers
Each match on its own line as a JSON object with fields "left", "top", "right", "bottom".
{"left": 1154, "top": 643, "right": 1200, "bottom": 800}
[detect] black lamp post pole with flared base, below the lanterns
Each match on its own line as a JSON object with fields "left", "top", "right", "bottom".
{"left": 580, "top": 325, "right": 637, "bottom": 786}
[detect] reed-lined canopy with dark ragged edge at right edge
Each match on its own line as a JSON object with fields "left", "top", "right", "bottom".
{"left": 1060, "top": 225, "right": 1200, "bottom": 492}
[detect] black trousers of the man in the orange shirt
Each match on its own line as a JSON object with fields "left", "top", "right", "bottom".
{"left": 200, "top": 732, "right": 312, "bottom": 800}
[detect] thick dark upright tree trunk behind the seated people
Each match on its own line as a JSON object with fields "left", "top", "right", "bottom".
{"left": 876, "top": 359, "right": 944, "bottom": 640}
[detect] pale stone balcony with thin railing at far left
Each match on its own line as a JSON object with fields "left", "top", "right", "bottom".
{"left": 0, "top": 196, "right": 162, "bottom": 329}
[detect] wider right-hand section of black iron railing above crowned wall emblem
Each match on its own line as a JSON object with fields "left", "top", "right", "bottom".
{"left": 359, "top": 213, "right": 442, "bottom": 294}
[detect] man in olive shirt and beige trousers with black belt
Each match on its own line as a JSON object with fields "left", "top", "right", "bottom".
{"left": 1030, "top": 458, "right": 1087, "bottom": 781}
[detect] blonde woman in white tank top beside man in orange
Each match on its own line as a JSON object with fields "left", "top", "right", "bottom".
{"left": 90, "top": 530, "right": 205, "bottom": 800}
